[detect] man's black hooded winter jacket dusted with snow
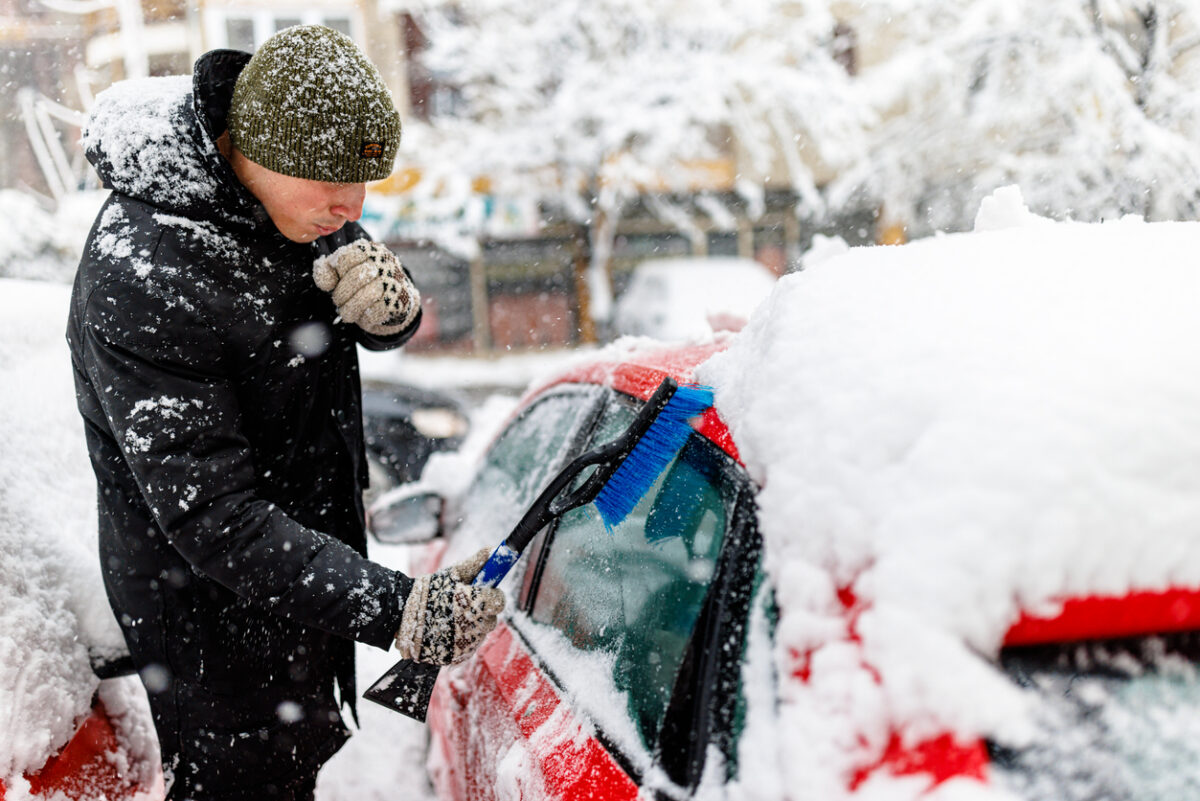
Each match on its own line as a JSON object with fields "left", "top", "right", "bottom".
{"left": 67, "top": 50, "right": 419, "bottom": 786}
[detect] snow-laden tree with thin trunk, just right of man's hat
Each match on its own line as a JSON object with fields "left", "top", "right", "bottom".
{"left": 388, "top": 0, "right": 863, "bottom": 319}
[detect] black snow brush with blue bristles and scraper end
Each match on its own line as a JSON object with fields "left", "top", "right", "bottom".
{"left": 362, "top": 378, "right": 713, "bottom": 721}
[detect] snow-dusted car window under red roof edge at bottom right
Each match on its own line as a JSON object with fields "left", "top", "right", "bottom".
{"left": 991, "top": 632, "right": 1200, "bottom": 801}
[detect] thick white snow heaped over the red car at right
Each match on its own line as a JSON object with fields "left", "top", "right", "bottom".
{"left": 698, "top": 185, "right": 1200, "bottom": 799}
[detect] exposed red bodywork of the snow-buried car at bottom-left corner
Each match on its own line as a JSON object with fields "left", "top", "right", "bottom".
{"left": 0, "top": 701, "right": 149, "bottom": 801}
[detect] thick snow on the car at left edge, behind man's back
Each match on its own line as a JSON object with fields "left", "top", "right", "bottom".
{"left": 0, "top": 279, "right": 154, "bottom": 787}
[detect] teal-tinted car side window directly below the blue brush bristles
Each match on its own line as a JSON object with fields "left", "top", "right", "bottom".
{"left": 530, "top": 402, "right": 737, "bottom": 749}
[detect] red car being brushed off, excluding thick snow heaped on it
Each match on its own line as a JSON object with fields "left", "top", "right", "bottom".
{"left": 372, "top": 330, "right": 1200, "bottom": 801}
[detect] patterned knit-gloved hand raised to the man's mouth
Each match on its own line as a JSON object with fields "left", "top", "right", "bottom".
{"left": 312, "top": 239, "right": 421, "bottom": 337}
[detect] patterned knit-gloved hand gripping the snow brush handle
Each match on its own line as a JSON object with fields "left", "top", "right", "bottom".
{"left": 396, "top": 548, "right": 504, "bottom": 664}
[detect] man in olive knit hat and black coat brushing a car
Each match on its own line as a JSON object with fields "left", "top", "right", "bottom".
{"left": 67, "top": 26, "right": 503, "bottom": 801}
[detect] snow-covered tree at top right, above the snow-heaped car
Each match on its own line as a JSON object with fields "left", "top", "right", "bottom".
{"left": 828, "top": 0, "right": 1200, "bottom": 236}
